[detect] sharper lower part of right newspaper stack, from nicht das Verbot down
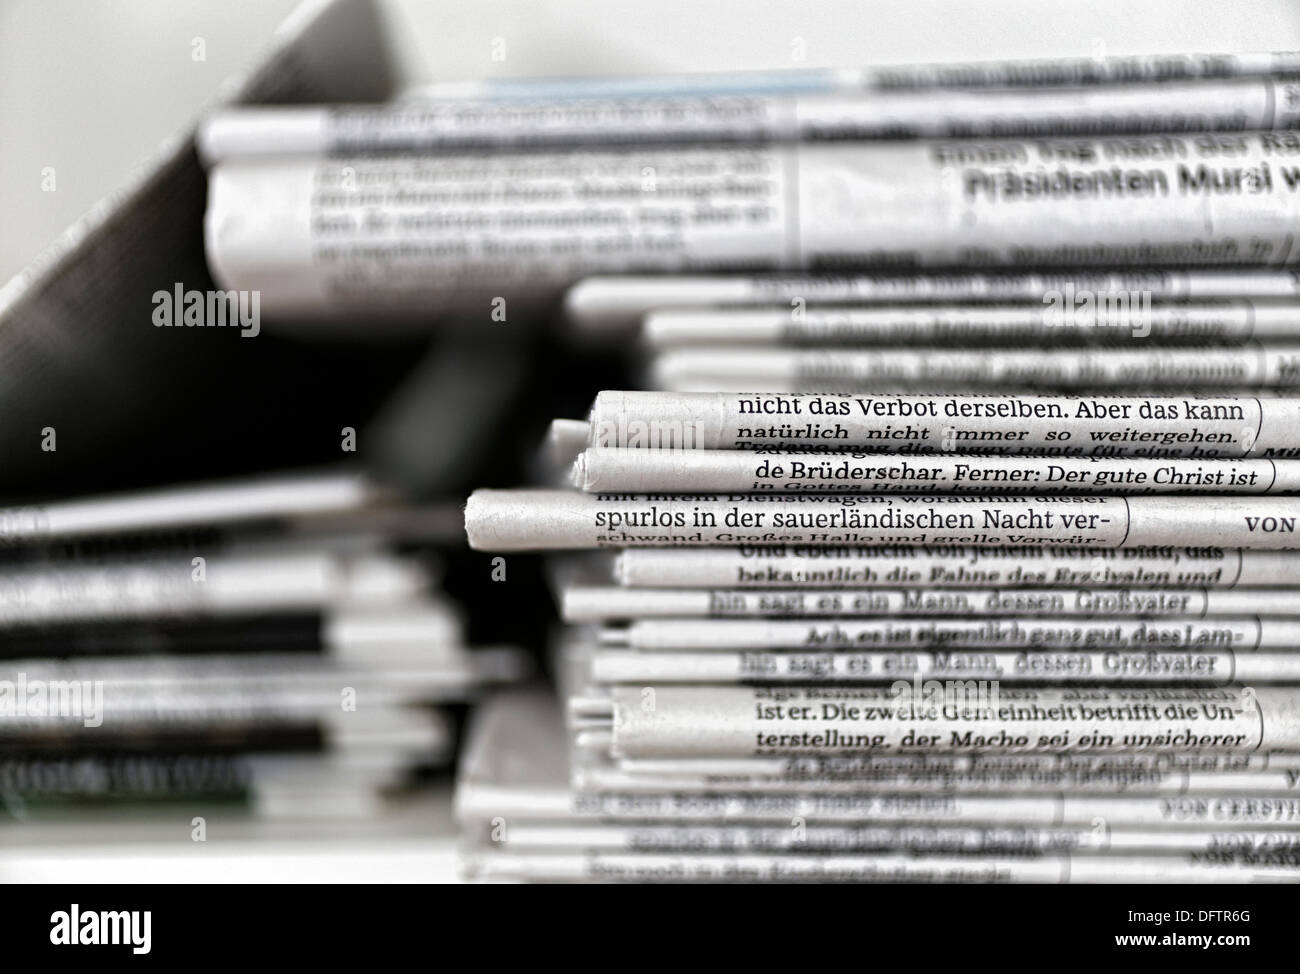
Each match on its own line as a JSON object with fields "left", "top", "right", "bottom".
{"left": 460, "top": 391, "right": 1300, "bottom": 882}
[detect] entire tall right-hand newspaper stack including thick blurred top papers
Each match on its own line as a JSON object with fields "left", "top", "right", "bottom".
{"left": 200, "top": 55, "right": 1300, "bottom": 882}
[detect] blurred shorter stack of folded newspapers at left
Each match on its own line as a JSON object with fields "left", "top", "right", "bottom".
{"left": 0, "top": 471, "right": 524, "bottom": 874}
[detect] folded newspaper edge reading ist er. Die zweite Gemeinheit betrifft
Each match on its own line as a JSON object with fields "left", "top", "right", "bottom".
{"left": 598, "top": 684, "right": 1300, "bottom": 757}
